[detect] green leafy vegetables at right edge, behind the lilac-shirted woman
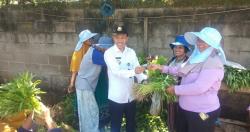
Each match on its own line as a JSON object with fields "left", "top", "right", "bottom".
{"left": 223, "top": 66, "right": 250, "bottom": 92}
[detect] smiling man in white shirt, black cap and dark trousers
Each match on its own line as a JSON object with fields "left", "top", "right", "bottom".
{"left": 104, "top": 26, "right": 147, "bottom": 132}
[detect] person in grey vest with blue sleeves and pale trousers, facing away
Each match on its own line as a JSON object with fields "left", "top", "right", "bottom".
{"left": 75, "top": 37, "right": 112, "bottom": 132}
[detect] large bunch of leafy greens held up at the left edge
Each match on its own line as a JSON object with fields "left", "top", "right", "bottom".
{"left": 0, "top": 72, "right": 44, "bottom": 118}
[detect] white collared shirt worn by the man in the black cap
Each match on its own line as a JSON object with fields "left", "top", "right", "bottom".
{"left": 104, "top": 45, "right": 147, "bottom": 103}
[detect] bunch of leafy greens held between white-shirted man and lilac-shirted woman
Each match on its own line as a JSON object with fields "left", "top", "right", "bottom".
{"left": 134, "top": 56, "right": 176, "bottom": 115}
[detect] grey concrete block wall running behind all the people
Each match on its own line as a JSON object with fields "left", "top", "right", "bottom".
{"left": 0, "top": 7, "right": 250, "bottom": 91}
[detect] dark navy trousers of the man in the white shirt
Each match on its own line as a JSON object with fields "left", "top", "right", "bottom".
{"left": 109, "top": 100, "right": 136, "bottom": 132}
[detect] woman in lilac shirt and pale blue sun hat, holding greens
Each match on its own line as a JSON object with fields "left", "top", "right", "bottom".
{"left": 149, "top": 27, "right": 226, "bottom": 132}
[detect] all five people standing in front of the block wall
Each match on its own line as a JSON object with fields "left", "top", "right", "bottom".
{"left": 68, "top": 26, "right": 226, "bottom": 132}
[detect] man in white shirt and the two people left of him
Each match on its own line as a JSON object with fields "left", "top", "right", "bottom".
{"left": 68, "top": 26, "right": 147, "bottom": 132}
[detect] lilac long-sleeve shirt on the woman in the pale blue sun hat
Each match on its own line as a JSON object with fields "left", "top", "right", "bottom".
{"left": 162, "top": 56, "right": 224, "bottom": 112}
